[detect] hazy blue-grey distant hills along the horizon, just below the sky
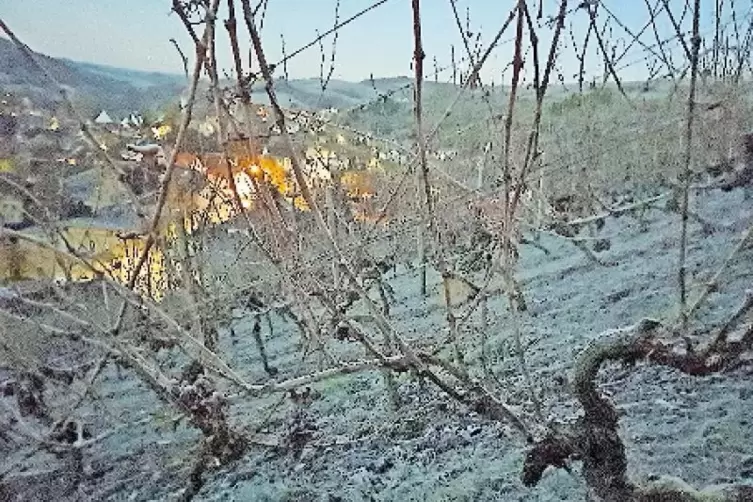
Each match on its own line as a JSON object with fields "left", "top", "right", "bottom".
{"left": 0, "top": 38, "right": 548, "bottom": 129}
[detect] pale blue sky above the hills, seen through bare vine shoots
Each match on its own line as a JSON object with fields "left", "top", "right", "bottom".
{"left": 0, "top": 0, "right": 750, "bottom": 83}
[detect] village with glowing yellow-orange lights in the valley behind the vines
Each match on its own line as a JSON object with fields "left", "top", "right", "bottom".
{"left": 0, "top": 88, "right": 451, "bottom": 297}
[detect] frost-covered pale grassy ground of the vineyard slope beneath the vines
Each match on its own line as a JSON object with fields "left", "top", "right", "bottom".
{"left": 0, "top": 186, "right": 753, "bottom": 501}
